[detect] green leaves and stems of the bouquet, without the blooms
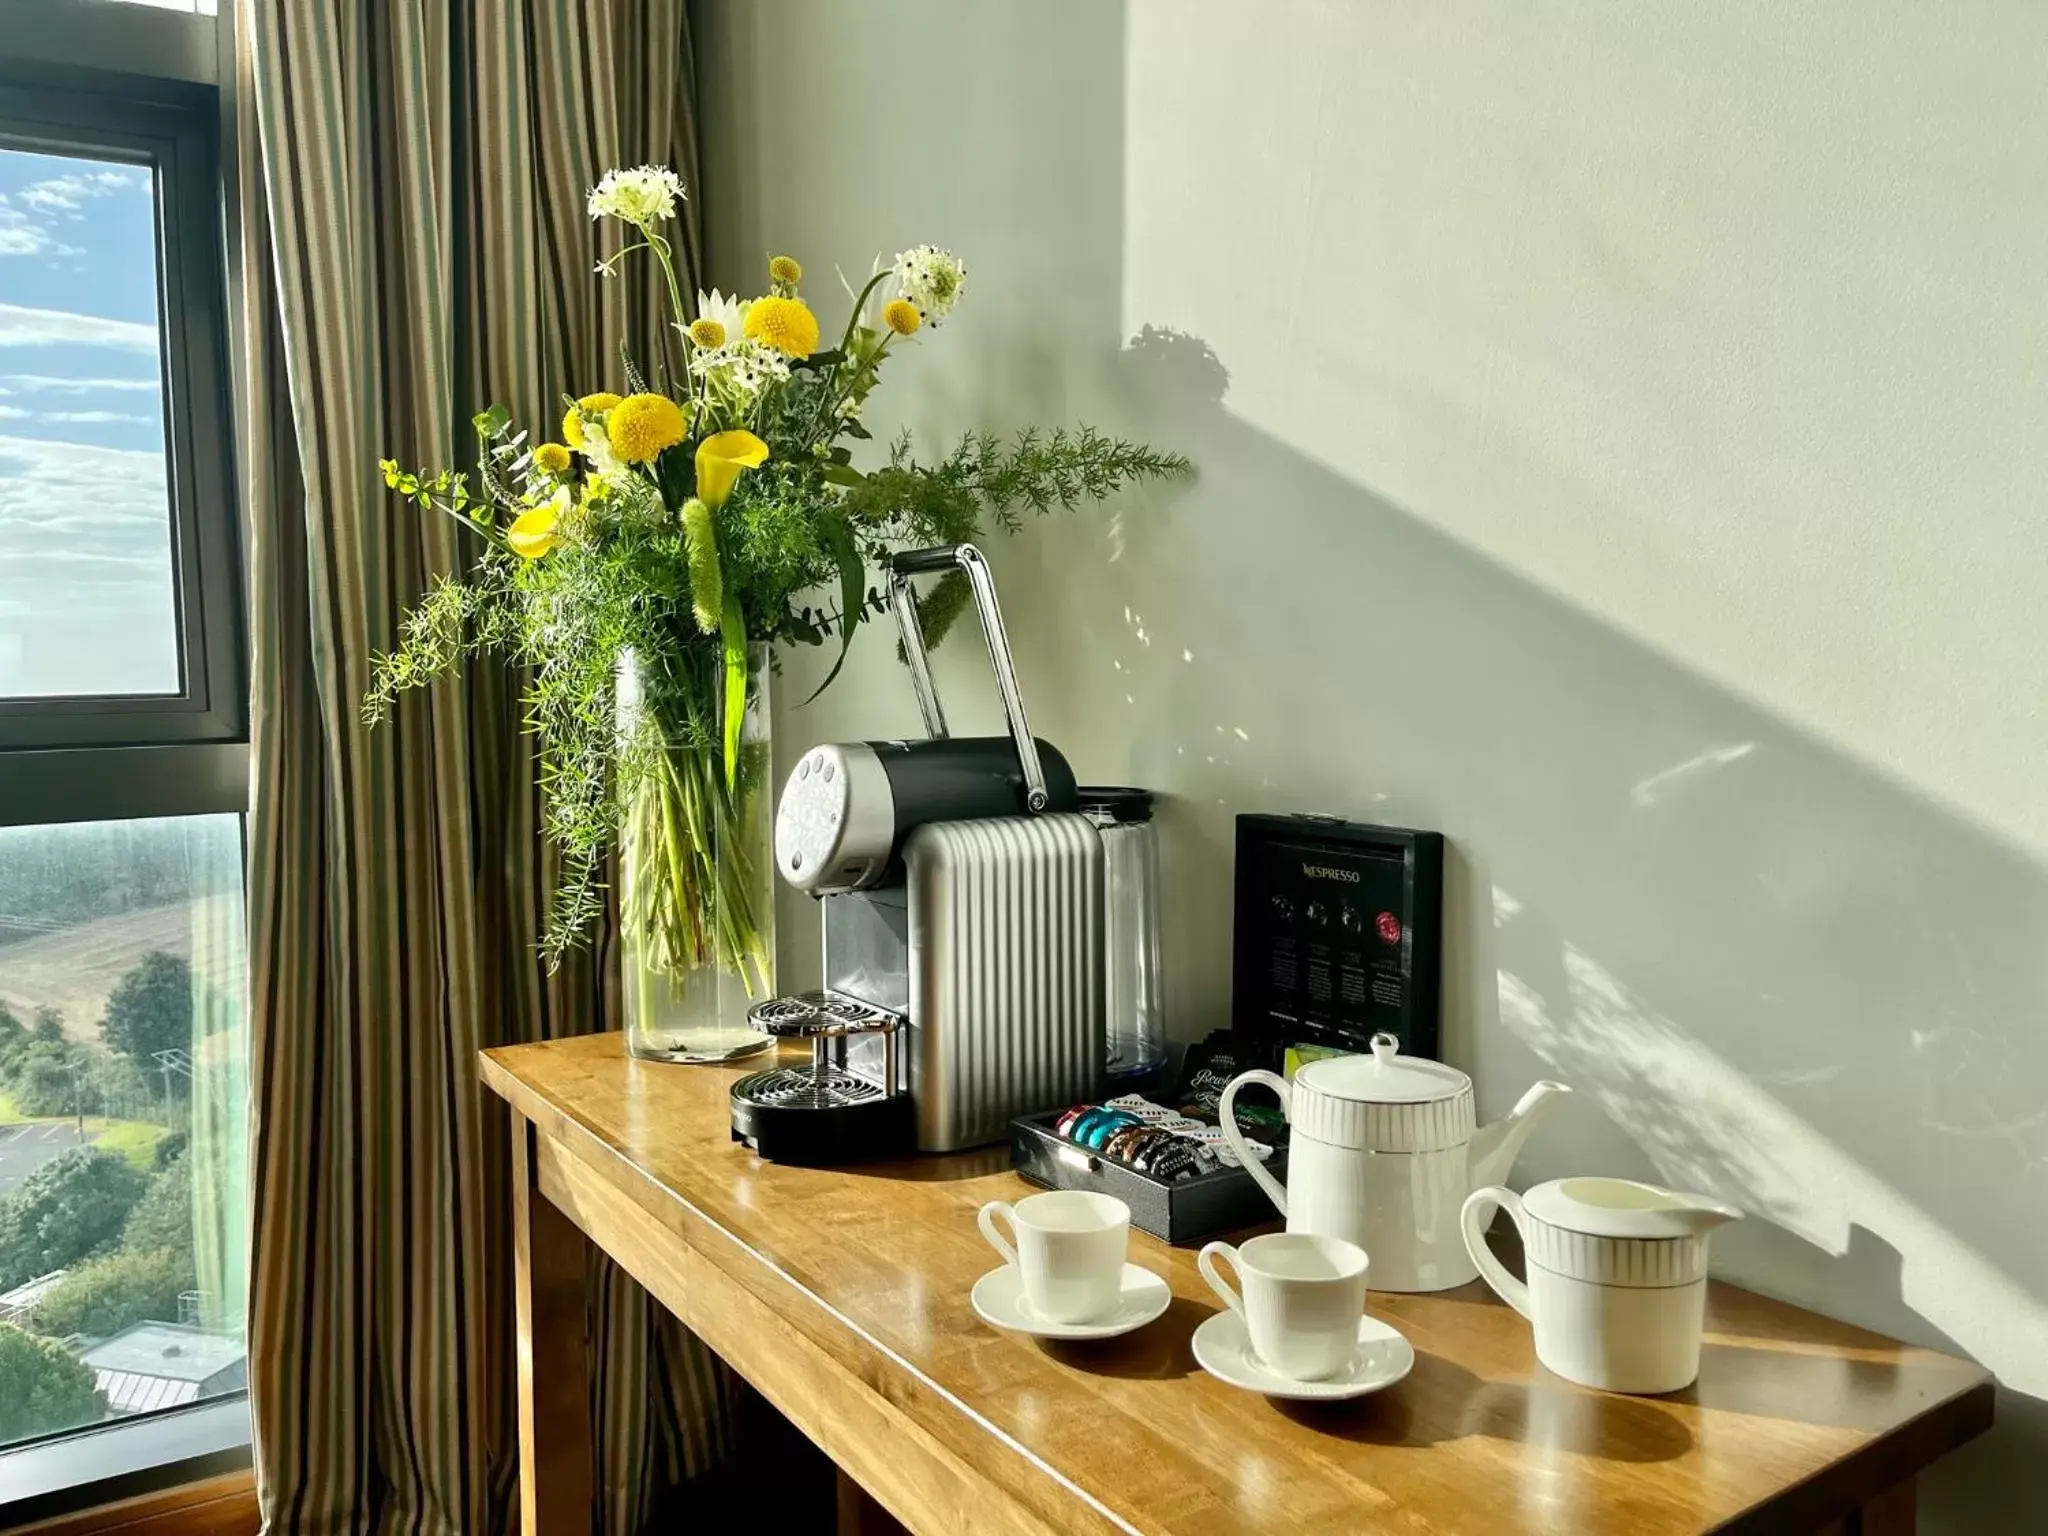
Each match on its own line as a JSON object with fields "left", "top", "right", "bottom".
{"left": 362, "top": 250, "right": 1188, "bottom": 967}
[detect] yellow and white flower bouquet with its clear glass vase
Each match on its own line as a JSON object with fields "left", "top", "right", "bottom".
{"left": 365, "top": 166, "right": 1188, "bottom": 1059}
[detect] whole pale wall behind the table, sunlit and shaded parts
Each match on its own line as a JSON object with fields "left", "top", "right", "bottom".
{"left": 698, "top": 0, "right": 2048, "bottom": 1532}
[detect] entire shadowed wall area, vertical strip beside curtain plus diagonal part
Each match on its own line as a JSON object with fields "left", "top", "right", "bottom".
{"left": 700, "top": 0, "right": 2048, "bottom": 1532}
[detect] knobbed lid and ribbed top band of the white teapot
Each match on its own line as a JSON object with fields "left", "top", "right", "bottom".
{"left": 1288, "top": 1034, "right": 1473, "bottom": 1153}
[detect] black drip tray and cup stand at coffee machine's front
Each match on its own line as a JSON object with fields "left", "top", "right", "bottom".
{"left": 731, "top": 991, "right": 918, "bottom": 1165}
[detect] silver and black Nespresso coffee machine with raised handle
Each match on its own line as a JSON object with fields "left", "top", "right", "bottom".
{"left": 731, "top": 545, "right": 1106, "bottom": 1163}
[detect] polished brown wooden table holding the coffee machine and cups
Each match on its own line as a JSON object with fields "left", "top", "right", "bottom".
{"left": 483, "top": 1034, "right": 1991, "bottom": 1536}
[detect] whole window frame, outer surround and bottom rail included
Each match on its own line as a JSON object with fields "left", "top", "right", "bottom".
{"left": 0, "top": 0, "right": 250, "bottom": 1528}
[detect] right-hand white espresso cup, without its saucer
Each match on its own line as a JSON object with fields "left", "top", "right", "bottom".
{"left": 1196, "top": 1233, "right": 1366, "bottom": 1380}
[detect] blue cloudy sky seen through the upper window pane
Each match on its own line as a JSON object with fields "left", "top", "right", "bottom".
{"left": 0, "top": 150, "right": 180, "bottom": 698}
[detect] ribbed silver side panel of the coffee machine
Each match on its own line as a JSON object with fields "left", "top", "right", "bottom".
{"left": 903, "top": 815, "right": 1108, "bottom": 1151}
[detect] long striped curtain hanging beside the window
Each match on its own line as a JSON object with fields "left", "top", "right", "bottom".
{"left": 240, "top": 0, "right": 729, "bottom": 1536}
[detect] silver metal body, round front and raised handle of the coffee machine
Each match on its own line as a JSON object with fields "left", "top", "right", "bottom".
{"left": 776, "top": 545, "right": 1108, "bottom": 1151}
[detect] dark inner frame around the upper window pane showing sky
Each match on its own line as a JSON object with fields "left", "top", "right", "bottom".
{"left": 0, "top": 61, "right": 248, "bottom": 774}
